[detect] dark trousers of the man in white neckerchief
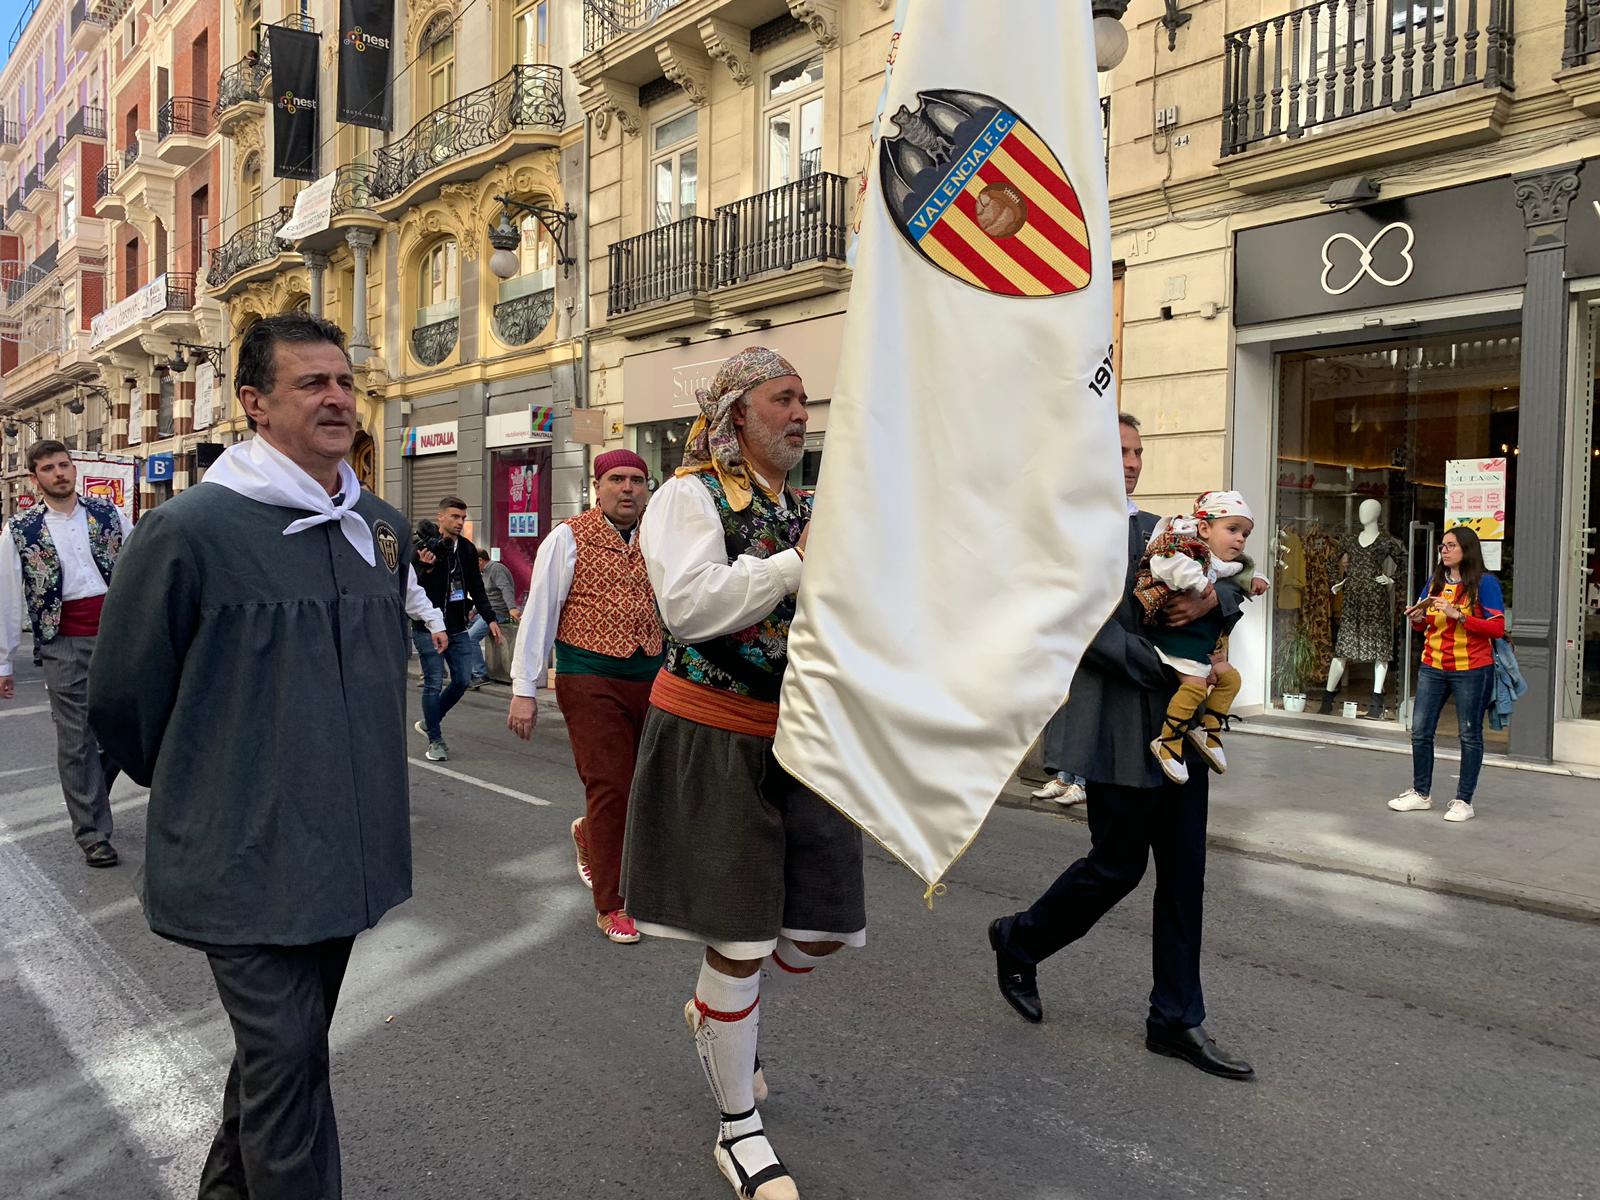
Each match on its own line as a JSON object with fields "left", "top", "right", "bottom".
{"left": 200, "top": 938, "right": 355, "bottom": 1200}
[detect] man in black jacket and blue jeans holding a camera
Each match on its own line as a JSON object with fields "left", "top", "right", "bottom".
{"left": 411, "top": 496, "right": 501, "bottom": 763}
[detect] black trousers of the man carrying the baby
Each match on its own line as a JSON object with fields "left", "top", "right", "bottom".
{"left": 1002, "top": 770, "right": 1210, "bottom": 1029}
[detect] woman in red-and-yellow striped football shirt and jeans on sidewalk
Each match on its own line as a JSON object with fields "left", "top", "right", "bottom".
{"left": 1389, "top": 525, "right": 1506, "bottom": 821}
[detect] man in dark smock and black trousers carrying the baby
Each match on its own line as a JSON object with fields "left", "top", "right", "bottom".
{"left": 989, "top": 413, "right": 1254, "bottom": 1078}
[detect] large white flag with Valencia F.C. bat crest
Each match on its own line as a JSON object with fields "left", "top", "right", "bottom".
{"left": 774, "top": 0, "right": 1128, "bottom": 885}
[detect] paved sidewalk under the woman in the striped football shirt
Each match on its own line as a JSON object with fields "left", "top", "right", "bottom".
{"left": 1000, "top": 730, "right": 1600, "bottom": 922}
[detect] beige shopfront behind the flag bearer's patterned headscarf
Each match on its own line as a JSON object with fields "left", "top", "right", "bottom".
{"left": 622, "top": 315, "right": 845, "bottom": 490}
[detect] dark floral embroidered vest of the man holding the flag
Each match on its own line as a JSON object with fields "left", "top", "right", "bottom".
{"left": 662, "top": 470, "right": 811, "bottom": 704}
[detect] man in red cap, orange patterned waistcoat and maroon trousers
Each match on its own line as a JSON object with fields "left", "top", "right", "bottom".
{"left": 506, "top": 450, "right": 662, "bottom": 944}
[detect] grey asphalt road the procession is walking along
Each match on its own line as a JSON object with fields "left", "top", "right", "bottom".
{"left": 0, "top": 674, "right": 1600, "bottom": 1200}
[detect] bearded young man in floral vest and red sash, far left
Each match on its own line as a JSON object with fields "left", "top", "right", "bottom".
{"left": 0, "top": 440, "right": 133, "bottom": 867}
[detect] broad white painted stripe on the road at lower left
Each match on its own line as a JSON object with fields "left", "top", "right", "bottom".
{"left": 0, "top": 824, "right": 222, "bottom": 1200}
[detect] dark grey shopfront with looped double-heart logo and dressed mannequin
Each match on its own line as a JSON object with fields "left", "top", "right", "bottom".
{"left": 1230, "top": 168, "right": 1600, "bottom": 758}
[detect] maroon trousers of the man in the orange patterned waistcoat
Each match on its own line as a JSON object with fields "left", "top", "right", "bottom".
{"left": 555, "top": 672, "right": 651, "bottom": 912}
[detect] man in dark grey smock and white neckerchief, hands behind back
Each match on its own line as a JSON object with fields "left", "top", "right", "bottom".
{"left": 90, "top": 314, "right": 411, "bottom": 1200}
